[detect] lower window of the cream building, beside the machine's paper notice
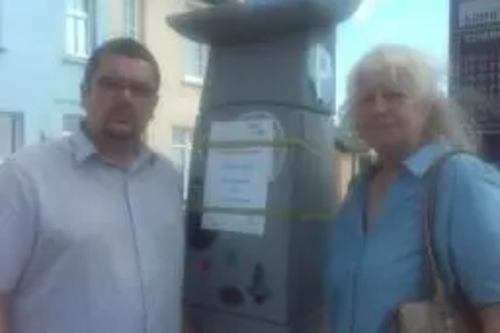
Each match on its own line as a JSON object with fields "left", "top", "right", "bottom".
{"left": 172, "top": 127, "right": 193, "bottom": 199}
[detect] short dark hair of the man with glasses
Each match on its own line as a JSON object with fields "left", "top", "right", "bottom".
{"left": 82, "top": 37, "right": 161, "bottom": 89}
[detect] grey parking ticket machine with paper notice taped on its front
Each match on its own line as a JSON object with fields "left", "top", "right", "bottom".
{"left": 168, "top": 0, "right": 359, "bottom": 333}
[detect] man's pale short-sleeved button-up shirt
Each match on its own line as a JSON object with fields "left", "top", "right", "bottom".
{"left": 0, "top": 133, "right": 184, "bottom": 333}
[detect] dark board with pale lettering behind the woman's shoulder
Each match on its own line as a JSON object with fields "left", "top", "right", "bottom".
{"left": 450, "top": 0, "right": 500, "bottom": 161}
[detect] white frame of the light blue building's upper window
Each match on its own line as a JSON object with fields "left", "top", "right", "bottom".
{"left": 65, "top": 0, "right": 96, "bottom": 60}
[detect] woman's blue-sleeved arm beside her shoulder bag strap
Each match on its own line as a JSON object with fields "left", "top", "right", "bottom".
{"left": 447, "top": 156, "right": 500, "bottom": 333}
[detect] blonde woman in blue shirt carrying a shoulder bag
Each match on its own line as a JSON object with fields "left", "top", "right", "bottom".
{"left": 326, "top": 45, "right": 500, "bottom": 333}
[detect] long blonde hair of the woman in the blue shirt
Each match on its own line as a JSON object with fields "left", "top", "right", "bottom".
{"left": 343, "top": 44, "right": 479, "bottom": 153}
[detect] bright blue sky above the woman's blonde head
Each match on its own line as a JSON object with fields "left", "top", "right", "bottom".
{"left": 336, "top": 0, "right": 449, "bottom": 112}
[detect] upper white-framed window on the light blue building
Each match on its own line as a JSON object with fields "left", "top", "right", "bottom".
{"left": 66, "top": 0, "right": 94, "bottom": 58}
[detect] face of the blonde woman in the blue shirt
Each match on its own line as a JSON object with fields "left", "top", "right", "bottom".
{"left": 352, "top": 72, "right": 427, "bottom": 155}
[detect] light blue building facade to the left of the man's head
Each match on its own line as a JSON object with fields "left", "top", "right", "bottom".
{"left": 0, "top": 0, "right": 110, "bottom": 160}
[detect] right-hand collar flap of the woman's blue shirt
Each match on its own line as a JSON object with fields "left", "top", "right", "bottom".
{"left": 403, "top": 139, "right": 452, "bottom": 177}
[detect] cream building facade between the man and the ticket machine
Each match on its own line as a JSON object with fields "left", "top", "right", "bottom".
{"left": 110, "top": 0, "right": 208, "bottom": 195}
